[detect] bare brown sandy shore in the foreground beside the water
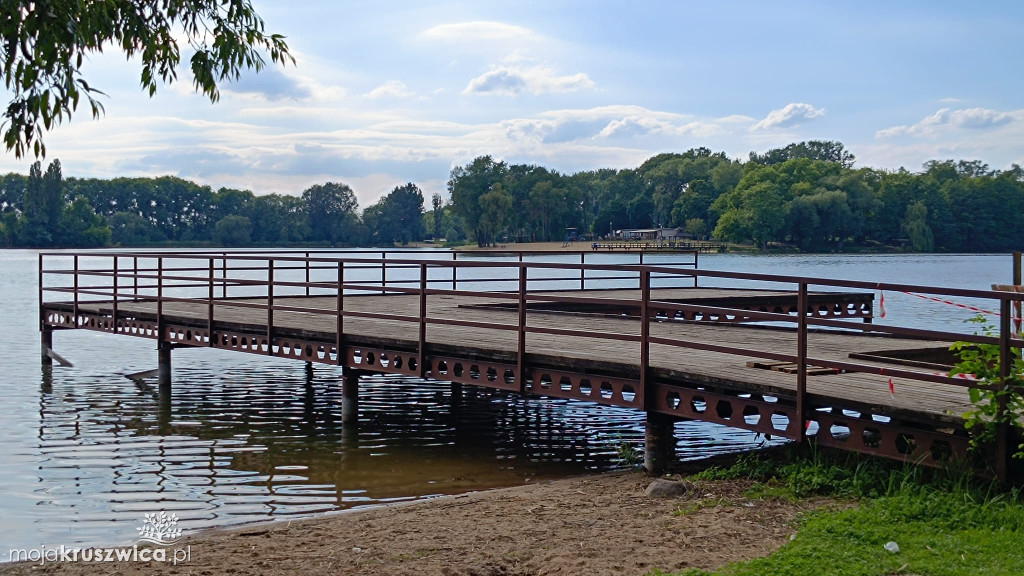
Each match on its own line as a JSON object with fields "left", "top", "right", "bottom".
{"left": 0, "top": 472, "right": 823, "bottom": 576}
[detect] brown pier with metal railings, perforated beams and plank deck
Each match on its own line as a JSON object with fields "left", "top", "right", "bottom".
{"left": 40, "top": 252, "right": 1024, "bottom": 476}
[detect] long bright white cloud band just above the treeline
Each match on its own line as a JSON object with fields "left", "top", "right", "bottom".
{"left": 19, "top": 100, "right": 752, "bottom": 206}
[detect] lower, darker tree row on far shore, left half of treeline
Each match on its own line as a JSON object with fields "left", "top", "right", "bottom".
{"left": 0, "top": 160, "right": 465, "bottom": 247}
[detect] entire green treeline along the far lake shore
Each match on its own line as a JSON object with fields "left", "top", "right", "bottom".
{"left": 0, "top": 140, "right": 1024, "bottom": 252}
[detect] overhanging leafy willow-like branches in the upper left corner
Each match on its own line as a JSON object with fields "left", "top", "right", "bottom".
{"left": 0, "top": 0, "right": 294, "bottom": 157}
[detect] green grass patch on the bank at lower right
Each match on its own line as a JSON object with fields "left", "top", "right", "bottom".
{"left": 655, "top": 453, "right": 1024, "bottom": 576}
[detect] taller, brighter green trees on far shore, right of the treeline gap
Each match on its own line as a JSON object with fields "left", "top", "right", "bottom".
{"left": 449, "top": 140, "right": 1024, "bottom": 252}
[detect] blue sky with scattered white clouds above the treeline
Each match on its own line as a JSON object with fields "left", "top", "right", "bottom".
{"left": 0, "top": 0, "right": 1024, "bottom": 207}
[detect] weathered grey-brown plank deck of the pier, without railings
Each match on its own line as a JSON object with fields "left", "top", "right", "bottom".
{"left": 47, "top": 288, "right": 970, "bottom": 436}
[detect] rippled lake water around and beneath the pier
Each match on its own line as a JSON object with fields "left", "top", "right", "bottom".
{"left": 0, "top": 250, "right": 1011, "bottom": 562}
